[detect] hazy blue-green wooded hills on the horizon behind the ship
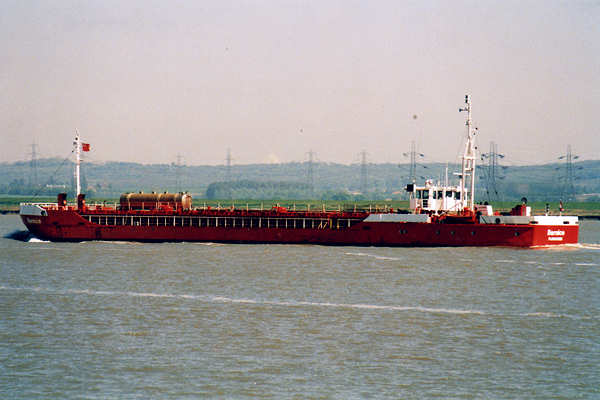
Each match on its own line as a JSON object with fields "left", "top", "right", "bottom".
{"left": 0, "top": 158, "right": 600, "bottom": 201}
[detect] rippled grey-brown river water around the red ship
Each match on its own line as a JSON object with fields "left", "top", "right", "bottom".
{"left": 0, "top": 216, "right": 600, "bottom": 399}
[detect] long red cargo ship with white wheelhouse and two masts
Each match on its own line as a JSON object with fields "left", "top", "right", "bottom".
{"left": 20, "top": 96, "right": 579, "bottom": 247}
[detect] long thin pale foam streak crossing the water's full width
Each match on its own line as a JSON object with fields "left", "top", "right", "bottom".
{"left": 0, "top": 286, "right": 598, "bottom": 319}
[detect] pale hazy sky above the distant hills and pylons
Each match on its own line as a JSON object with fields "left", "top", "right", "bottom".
{"left": 0, "top": 0, "right": 600, "bottom": 165}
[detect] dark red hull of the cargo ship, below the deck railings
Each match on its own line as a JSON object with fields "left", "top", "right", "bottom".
{"left": 22, "top": 209, "right": 579, "bottom": 247}
